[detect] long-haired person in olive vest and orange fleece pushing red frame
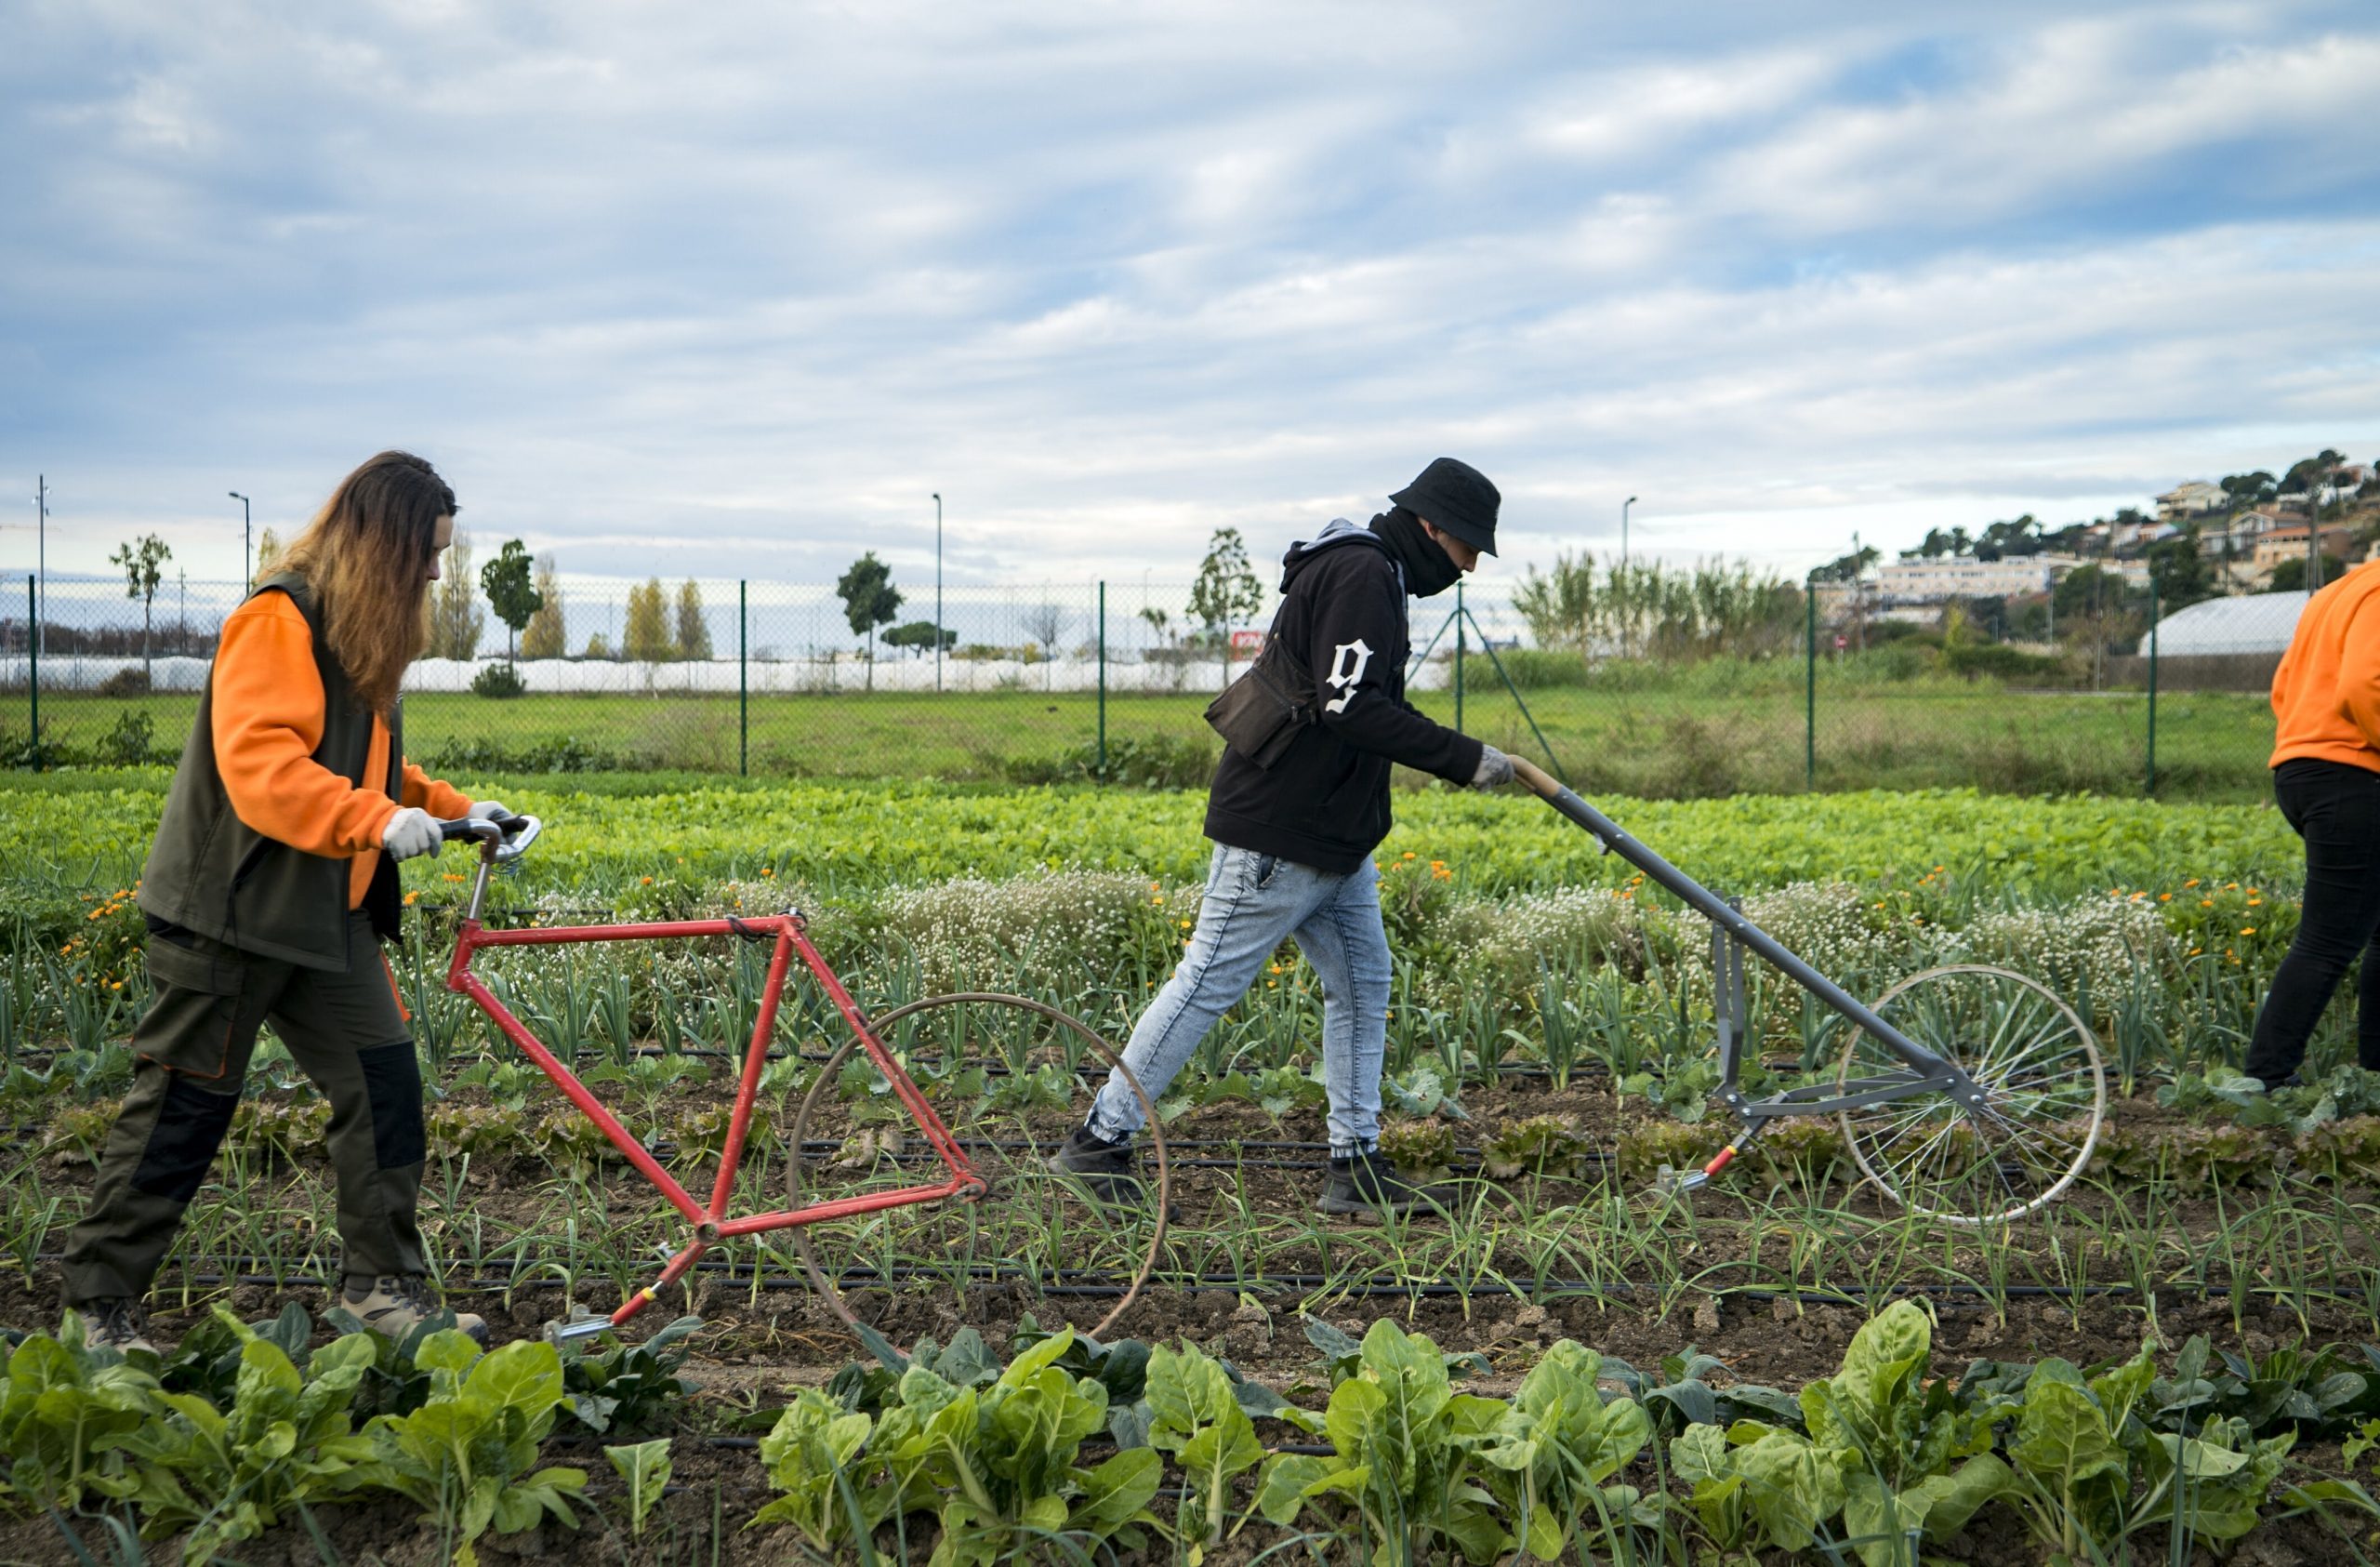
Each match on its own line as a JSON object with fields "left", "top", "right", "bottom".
{"left": 64, "top": 453, "right": 509, "bottom": 1350}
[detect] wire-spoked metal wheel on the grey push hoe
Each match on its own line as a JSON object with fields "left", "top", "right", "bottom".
{"left": 1835, "top": 964, "right": 2107, "bottom": 1228}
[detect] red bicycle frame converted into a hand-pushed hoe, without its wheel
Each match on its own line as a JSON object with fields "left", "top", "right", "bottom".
{"left": 447, "top": 867, "right": 985, "bottom": 1338}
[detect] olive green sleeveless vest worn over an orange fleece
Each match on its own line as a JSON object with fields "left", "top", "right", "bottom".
{"left": 140, "top": 572, "right": 404, "bottom": 969}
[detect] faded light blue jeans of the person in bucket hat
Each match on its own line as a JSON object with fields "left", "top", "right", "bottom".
{"left": 1090, "top": 845, "right": 1387, "bottom": 1158}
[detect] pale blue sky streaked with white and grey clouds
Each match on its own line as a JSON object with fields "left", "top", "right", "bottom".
{"left": 0, "top": 0, "right": 2380, "bottom": 581}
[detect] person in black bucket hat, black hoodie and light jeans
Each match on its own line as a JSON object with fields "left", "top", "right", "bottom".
{"left": 1050, "top": 458, "right": 1512, "bottom": 1217}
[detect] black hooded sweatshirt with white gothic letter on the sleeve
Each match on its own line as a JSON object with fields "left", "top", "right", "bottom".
{"left": 1207, "top": 519, "right": 1483, "bottom": 876}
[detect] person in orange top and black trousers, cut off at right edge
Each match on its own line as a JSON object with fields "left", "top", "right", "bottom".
{"left": 2242, "top": 566, "right": 2380, "bottom": 1088}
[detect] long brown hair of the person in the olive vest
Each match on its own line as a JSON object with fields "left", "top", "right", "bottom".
{"left": 281, "top": 453, "right": 455, "bottom": 714}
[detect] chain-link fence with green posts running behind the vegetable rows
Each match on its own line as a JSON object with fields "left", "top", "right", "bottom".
{"left": 0, "top": 577, "right": 2304, "bottom": 798}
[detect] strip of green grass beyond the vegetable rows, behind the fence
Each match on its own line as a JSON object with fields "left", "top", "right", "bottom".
{"left": 0, "top": 676, "right": 2273, "bottom": 800}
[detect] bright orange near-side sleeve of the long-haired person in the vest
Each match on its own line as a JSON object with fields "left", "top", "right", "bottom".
{"left": 212, "top": 593, "right": 398, "bottom": 859}
